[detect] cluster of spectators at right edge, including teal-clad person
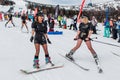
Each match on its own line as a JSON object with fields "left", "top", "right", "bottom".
{"left": 104, "top": 17, "right": 120, "bottom": 43}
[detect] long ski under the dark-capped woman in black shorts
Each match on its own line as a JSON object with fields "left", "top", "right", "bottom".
{"left": 20, "top": 64, "right": 64, "bottom": 74}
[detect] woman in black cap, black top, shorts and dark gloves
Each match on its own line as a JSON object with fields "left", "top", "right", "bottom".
{"left": 30, "top": 12, "right": 53, "bottom": 68}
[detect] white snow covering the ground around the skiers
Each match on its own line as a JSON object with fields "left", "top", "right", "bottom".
{"left": 0, "top": 18, "right": 120, "bottom": 80}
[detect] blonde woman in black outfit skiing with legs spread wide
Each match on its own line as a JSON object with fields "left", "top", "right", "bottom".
{"left": 66, "top": 17, "right": 98, "bottom": 61}
